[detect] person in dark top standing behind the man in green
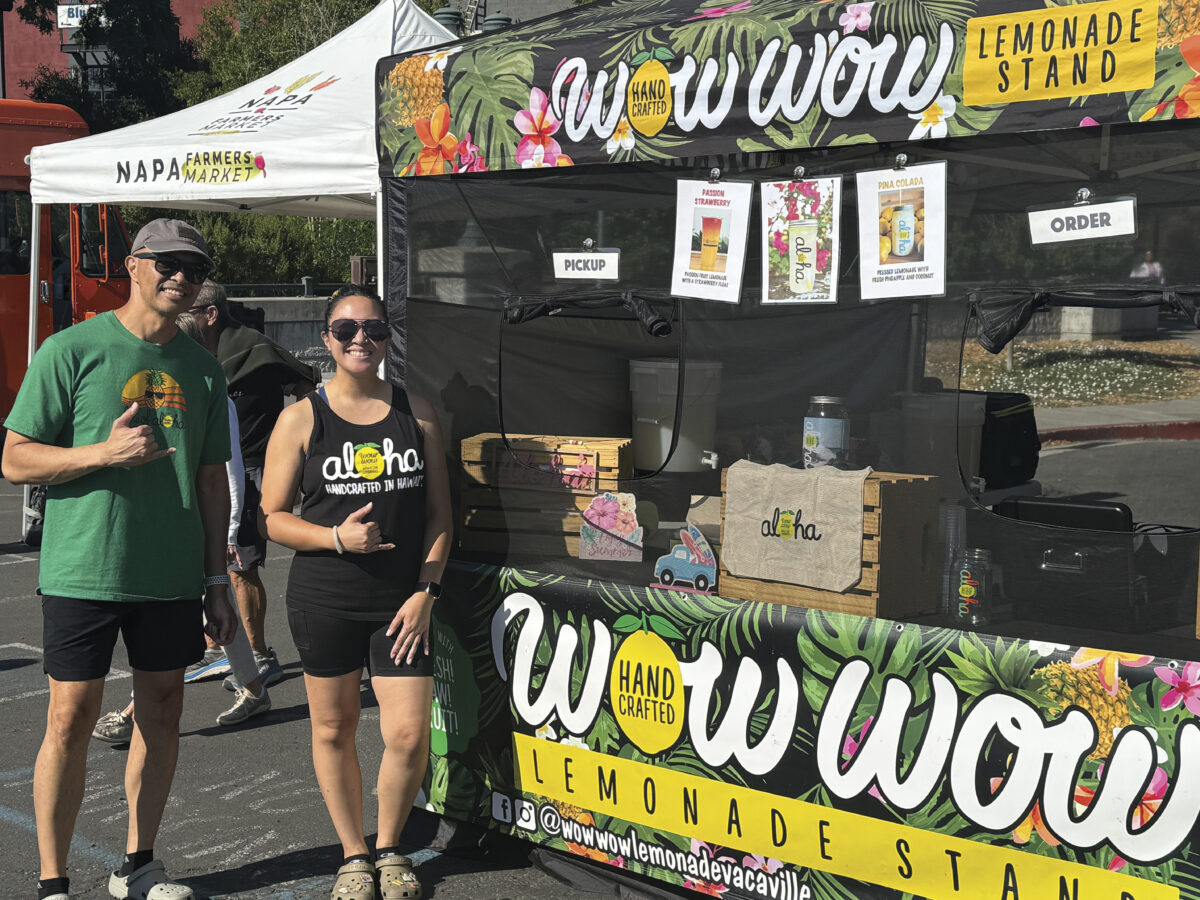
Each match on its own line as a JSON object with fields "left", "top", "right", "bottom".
{"left": 185, "top": 281, "right": 319, "bottom": 690}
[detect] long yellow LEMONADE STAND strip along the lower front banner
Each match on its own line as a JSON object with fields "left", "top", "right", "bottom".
{"left": 512, "top": 734, "right": 1180, "bottom": 900}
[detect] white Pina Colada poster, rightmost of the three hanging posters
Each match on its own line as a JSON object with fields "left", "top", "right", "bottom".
{"left": 858, "top": 162, "right": 946, "bottom": 300}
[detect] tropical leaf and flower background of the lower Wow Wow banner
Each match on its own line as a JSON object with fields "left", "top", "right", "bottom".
{"left": 425, "top": 563, "right": 1200, "bottom": 900}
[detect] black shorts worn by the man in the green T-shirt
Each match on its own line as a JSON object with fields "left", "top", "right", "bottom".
{"left": 42, "top": 596, "right": 204, "bottom": 682}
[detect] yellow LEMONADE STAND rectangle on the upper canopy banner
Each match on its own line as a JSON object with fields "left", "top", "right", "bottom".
{"left": 962, "top": 0, "right": 1158, "bottom": 107}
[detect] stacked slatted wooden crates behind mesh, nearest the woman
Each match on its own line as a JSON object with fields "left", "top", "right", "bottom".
{"left": 458, "top": 433, "right": 634, "bottom": 557}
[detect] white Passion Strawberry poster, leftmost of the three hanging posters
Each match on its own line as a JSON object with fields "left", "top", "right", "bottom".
{"left": 671, "top": 181, "right": 754, "bottom": 304}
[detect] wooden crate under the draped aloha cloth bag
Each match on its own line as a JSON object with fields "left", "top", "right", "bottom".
{"left": 718, "top": 472, "right": 941, "bottom": 618}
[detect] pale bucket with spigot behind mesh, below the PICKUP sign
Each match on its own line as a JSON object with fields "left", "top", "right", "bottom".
{"left": 629, "top": 359, "right": 721, "bottom": 472}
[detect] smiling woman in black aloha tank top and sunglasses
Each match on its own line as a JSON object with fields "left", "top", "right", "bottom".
{"left": 262, "top": 288, "right": 451, "bottom": 900}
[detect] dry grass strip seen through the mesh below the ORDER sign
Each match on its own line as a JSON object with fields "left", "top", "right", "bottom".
{"left": 925, "top": 340, "right": 1200, "bottom": 407}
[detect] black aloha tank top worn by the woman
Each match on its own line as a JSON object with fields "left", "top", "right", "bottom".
{"left": 287, "top": 388, "right": 425, "bottom": 619}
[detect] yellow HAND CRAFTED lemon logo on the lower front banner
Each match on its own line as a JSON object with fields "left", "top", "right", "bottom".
{"left": 608, "top": 616, "right": 684, "bottom": 756}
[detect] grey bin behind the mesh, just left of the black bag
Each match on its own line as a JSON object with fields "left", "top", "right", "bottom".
{"left": 900, "top": 391, "right": 986, "bottom": 484}
